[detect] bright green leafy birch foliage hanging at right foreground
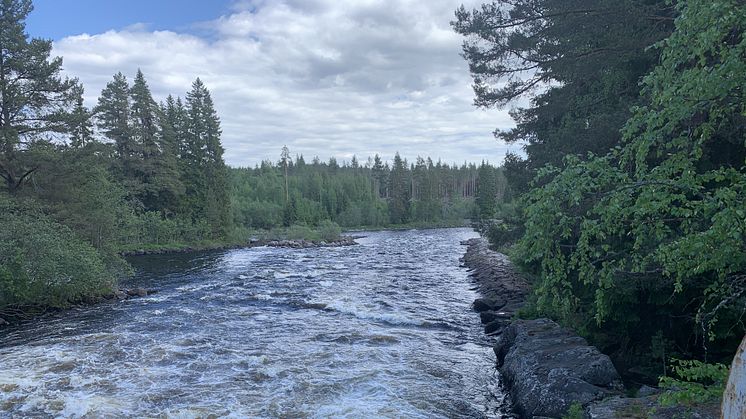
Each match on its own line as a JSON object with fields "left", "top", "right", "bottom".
{"left": 502, "top": 0, "right": 746, "bottom": 364}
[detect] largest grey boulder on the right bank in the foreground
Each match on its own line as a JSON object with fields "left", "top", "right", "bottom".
{"left": 495, "top": 319, "right": 623, "bottom": 417}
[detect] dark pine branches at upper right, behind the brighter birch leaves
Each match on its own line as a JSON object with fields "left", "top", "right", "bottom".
{"left": 452, "top": 0, "right": 673, "bottom": 193}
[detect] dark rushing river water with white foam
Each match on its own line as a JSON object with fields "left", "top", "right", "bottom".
{"left": 0, "top": 229, "right": 504, "bottom": 418}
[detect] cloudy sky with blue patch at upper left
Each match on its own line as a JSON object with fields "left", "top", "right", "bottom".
{"left": 27, "top": 0, "right": 518, "bottom": 166}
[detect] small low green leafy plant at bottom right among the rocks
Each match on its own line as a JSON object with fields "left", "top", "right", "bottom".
{"left": 658, "top": 359, "right": 728, "bottom": 407}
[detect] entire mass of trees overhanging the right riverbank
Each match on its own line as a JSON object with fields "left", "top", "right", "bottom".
{"left": 453, "top": 0, "right": 746, "bottom": 390}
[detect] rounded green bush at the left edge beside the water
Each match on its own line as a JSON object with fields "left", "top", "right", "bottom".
{"left": 0, "top": 194, "right": 115, "bottom": 310}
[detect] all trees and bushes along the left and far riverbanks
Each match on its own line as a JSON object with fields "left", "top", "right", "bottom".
{"left": 0, "top": 0, "right": 505, "bottom": 318}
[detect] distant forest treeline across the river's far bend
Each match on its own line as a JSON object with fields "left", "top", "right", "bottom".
{"left": 230, "top": 148, "right": 506, "bottom": 229}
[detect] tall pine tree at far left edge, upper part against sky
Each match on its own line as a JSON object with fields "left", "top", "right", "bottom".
{"left": 0, "top": 0, "right": 77, "bottom": 193}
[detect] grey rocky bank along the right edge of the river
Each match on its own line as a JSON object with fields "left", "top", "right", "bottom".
{"left": 462, "top": 239, "right": 717, "bottom": 419}
